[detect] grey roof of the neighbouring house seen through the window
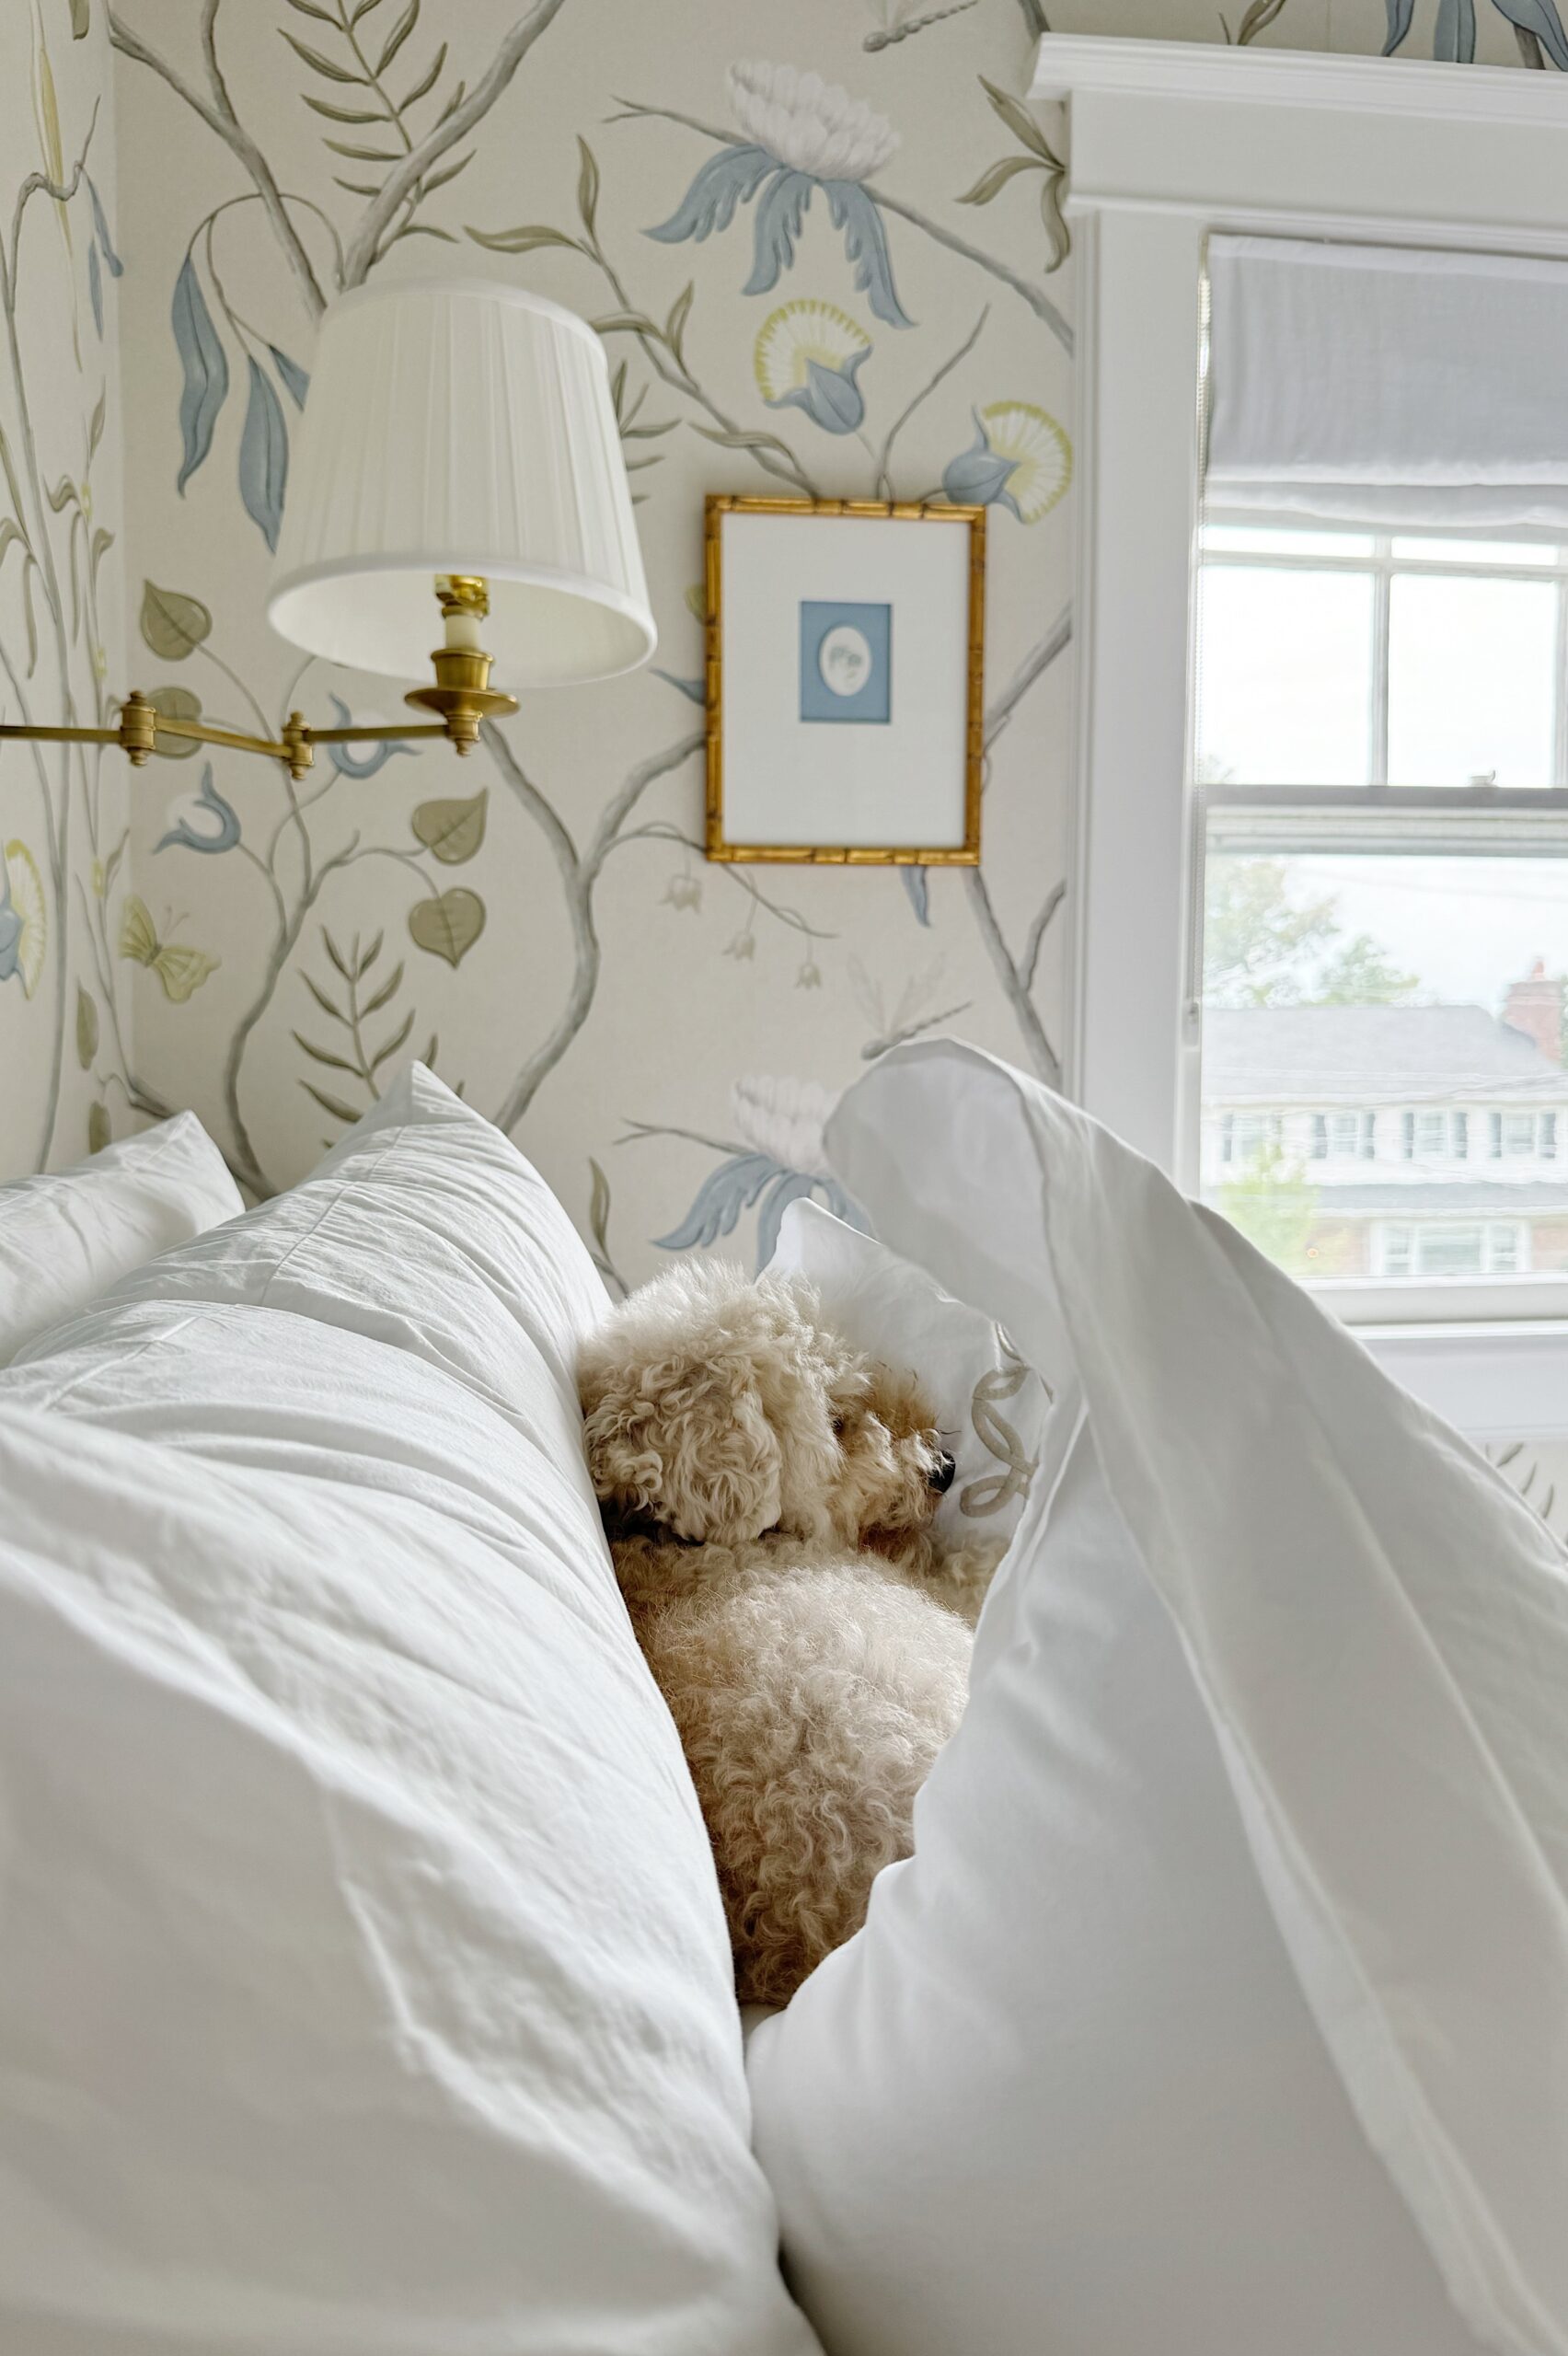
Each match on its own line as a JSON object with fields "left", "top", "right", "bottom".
{"left": 1203, "top": 1006, "right": 1568, "bottom": 1105}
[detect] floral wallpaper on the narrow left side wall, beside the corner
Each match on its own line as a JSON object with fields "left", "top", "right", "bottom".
{"left": 0, "top": 14, "right": 136, "bottom": 1196}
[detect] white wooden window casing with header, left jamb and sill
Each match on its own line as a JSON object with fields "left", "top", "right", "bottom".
{"left": 1032, "top": 33, "right": 1568, "bottom": 1438}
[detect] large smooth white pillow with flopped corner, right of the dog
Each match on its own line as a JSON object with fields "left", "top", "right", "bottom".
{"left": 751, "top": 1044, "right": 1568, "bottom": 2356}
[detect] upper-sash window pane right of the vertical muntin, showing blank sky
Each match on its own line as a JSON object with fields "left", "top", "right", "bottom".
{"left": 1389, "top": 572, "right": 1556, "bottom": 784}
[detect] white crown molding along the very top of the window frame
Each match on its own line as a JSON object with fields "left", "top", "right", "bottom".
{"left": 1029, "top": 33, "right": 1568, "bottom": 130}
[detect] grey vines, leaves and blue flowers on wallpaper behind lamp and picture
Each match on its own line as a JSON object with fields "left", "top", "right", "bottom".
{"left": 110, "top": 0, "right": 1071, "bottom": 1261}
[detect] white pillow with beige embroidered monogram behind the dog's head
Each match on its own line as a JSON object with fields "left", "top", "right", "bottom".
{"left": 767, "top": 1202, "right": 1050, "bottom": 1548}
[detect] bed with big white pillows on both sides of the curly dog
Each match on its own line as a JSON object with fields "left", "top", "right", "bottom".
{"left": 0, "top": 1044, "right": 1568, "bottom": 2356}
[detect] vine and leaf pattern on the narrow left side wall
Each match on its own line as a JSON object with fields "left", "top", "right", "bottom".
{"left": 0, "top": 0, "right": 133, "bottom": 1169}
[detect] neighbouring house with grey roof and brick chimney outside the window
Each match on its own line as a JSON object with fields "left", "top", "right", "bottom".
{"left": 1201, "top": 966, "right": 1568, "bottom": 1282}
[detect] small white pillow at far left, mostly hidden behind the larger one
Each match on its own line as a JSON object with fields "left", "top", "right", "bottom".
{"left": 0, "top": 1112, "right": 245, "bottom": 1367}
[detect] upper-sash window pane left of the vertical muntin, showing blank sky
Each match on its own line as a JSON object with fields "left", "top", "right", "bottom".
{"left": 1198, "top": 565, "right": 1365, "bottom": 784}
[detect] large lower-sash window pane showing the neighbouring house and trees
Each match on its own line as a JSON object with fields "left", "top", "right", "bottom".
{"left": 1201, "top": 850, "right": 1568, "bottom": 1288}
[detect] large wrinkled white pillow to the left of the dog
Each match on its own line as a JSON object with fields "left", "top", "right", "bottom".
{"left": 0, "top": 1072, "right": 814, "bottom": 2356}
